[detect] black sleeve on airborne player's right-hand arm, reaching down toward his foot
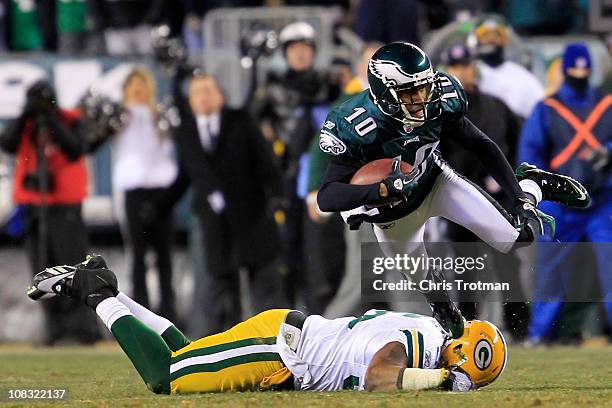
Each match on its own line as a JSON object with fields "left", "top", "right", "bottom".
{"left": 448, "top": 117, "right": 525, "bottom": 200}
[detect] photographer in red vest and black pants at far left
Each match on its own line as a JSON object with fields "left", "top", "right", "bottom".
{"left": 0, "top": 80, "right": 99, "bottom": 345}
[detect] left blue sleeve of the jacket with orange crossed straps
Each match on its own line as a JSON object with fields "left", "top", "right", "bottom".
{"left": 518, "top": 104, "right": 549, "bottom": 169}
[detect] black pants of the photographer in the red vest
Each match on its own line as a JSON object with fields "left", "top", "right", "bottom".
{"left": 25, "top": 205, "right": 101, "bottom": 345}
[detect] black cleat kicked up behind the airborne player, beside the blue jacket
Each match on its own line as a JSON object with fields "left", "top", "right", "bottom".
{"left": 515, "top": 162, "right": 591, "bottom": 208}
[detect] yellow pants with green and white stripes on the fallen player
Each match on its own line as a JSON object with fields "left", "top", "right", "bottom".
{"left": 170, "top": 309, "right": 291, "bottom": 394}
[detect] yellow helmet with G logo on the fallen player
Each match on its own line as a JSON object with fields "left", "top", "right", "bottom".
{"left": 442, "top": 320, "right": 508, "bottom": 388}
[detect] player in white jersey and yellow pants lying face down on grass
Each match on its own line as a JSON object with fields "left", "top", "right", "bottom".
{"left": 28, "top": 256, "right": 507, "bottom": 394}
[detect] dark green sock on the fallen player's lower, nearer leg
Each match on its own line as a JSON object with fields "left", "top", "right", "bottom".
{"left": 111, "top": 316, "right": 171, "bottom": 394}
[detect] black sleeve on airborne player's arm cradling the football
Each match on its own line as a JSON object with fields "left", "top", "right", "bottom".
{"left": 317, "top": 159, "right": 380, "bottom": 212}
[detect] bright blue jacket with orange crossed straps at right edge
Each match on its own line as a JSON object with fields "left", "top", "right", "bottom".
{"left": 518, "top": 84, "right": 612, "bottom": 195}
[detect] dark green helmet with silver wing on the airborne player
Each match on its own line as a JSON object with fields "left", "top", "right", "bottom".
{"left": 368, "top": 42, "right": 442, "bottom": 127}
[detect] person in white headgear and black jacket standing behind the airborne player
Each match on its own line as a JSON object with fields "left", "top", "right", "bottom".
{"left": 253, "top": 22, "right": 337, "bottom": 308}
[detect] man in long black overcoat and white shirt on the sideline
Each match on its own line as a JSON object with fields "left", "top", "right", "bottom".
{"left": 157, "top": 71, "right": 285, "bottom": 332}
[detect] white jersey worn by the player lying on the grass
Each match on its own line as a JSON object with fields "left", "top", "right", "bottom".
{"left": 288, "top": 310, "right": 448, "bottom": 391}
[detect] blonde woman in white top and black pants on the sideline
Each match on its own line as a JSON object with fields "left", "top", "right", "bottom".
{"left": 112, "top": 67, "right": 178, "bottom": 319}
